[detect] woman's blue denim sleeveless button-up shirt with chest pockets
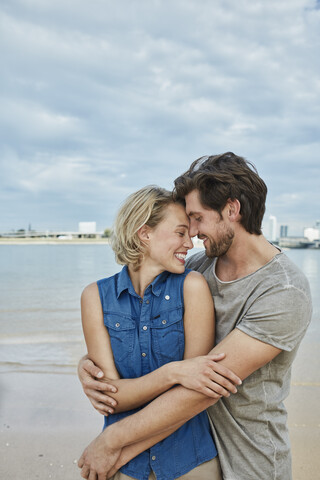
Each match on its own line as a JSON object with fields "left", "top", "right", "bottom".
{"left": 97, "top": 266, "right": 217, "bottom": 480}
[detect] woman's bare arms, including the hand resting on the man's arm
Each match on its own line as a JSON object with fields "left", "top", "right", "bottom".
{"left": 81, "top": 278, "right": 239, "bottom": 413}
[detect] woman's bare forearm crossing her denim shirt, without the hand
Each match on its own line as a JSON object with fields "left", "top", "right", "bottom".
{"left": 106, "top": 362, "right": 178, "bottom": 413}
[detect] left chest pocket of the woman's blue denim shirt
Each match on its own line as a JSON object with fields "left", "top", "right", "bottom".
{"left": 103, "top": 312, "right": 136, "bottom": 367}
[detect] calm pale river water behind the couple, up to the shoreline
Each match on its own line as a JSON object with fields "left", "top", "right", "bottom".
{"left": 0, "top": 244, "right": 320, "bottom": 373}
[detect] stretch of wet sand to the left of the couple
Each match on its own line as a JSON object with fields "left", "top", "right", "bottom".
{"left": 0, "top": 372, "right": 103, "bottom": 480}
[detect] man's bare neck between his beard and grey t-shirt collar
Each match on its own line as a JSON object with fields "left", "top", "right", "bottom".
{"left": 216, "top": 231, "right": 279, "bottom": 282}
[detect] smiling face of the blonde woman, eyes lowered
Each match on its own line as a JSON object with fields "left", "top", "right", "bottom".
{"left": 148, "top": 204, "right": 193, "bottom": 273}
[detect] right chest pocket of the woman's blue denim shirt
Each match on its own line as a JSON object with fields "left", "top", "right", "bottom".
{"left": 151, "top": 307, "right": 184, "bottom": 365}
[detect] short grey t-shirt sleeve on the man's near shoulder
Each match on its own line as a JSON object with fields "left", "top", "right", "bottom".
{"left": 236, "top": 285, "right": 312, "bottom": 351}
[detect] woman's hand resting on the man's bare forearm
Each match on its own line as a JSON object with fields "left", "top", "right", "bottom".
{"left": 172, "top": 353, "right": 242, "bottom": 398}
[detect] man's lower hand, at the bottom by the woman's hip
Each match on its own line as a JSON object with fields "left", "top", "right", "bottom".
{"left": 78, "top": 430, "right": 122, "bottom": 480}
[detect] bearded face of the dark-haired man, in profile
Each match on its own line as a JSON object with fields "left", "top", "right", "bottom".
{"left": 185, "top": 190, "right": 234, "bottom": 258}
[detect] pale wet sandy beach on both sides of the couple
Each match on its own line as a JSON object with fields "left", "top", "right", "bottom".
{"left": 0, "top": 339, "right": 320, "bottom": 480}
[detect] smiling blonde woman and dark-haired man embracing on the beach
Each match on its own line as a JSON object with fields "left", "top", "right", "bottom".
{"left": 78, "top": 152, "right": 312, "bottom": 480}
